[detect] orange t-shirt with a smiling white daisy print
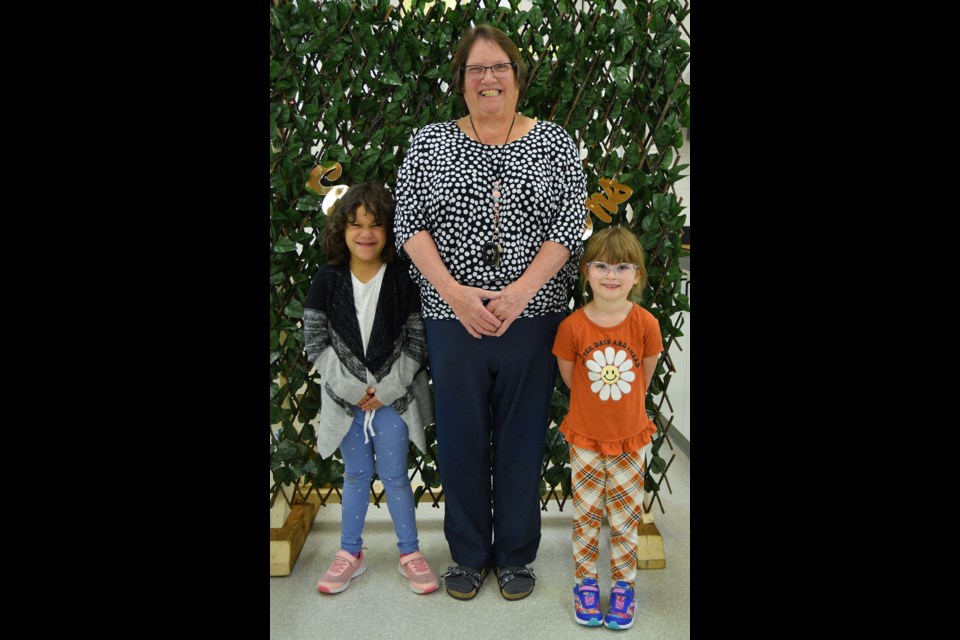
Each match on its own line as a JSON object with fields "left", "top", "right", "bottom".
{"left": 553, "top": 303, "right": 663, "bottom": 455}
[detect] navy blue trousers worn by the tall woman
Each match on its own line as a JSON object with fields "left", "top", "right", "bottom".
{"left": 425, "top": 313, "right": 565, "bottom": 570}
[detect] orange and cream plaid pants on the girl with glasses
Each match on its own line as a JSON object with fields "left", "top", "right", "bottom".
{"left": 570, "top": 445, "right": 643, "bottom": 583}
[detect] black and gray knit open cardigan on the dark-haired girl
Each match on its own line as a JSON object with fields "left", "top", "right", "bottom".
{"left": 303, "top": 262, "right": 433, "bottom": 458}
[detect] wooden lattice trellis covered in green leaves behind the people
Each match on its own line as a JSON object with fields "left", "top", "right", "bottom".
{"left": 270, "top": 0, "right": 689, "bottom": 511}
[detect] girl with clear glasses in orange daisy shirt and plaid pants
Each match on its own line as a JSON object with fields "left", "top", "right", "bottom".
{"left": 553, "top": 226, "right": 663, "bottom": 629}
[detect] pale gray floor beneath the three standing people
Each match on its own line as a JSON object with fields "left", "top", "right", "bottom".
{"left": 270, "top": 446, "right": 690, "bottom": 640}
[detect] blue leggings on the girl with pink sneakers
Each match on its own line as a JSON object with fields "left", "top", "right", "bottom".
{"left": 340, "top": 407, "right": 420, "bottom": 555}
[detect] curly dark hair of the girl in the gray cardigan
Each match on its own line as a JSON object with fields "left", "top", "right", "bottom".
{"left": 323, "top": 182, "right": 397, "bottom": 264}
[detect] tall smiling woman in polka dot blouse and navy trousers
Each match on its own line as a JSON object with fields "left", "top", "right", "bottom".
{"left": 396, "top": 26, "right": 587, "bottom": 600}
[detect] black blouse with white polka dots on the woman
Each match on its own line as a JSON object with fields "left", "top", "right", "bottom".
{"left": 394, "top": 120, "right": 587, "bottom": 320}
